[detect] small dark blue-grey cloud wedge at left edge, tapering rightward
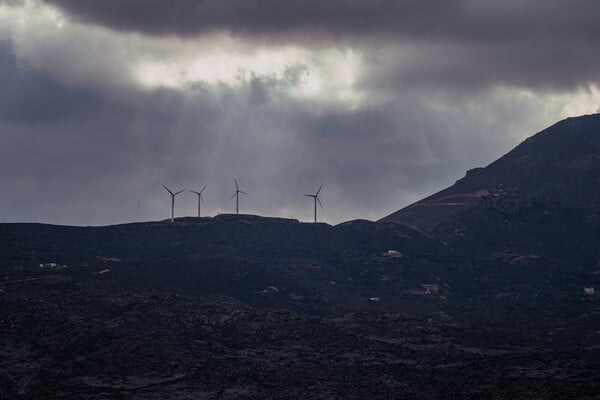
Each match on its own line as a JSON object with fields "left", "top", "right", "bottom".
{"left": 0, "top": 42, "right": 102, "bottom": 123}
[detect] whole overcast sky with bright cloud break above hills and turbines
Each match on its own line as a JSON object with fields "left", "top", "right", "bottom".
{"left": 0, "top": 0, "right": 600, "bottom": 225}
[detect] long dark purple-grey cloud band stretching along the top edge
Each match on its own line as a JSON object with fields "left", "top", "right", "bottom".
{"left": 45, "top": 0, "right": 600, "bottom": 41}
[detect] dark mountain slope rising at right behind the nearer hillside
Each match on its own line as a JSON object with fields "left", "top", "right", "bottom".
{"left": 381, "top": 114, "right": 600, "bottom": 228}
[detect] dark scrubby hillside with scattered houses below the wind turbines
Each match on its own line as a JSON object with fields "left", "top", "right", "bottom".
{"left": 0, "top": 211, "right": 600, "bottom": 399}
